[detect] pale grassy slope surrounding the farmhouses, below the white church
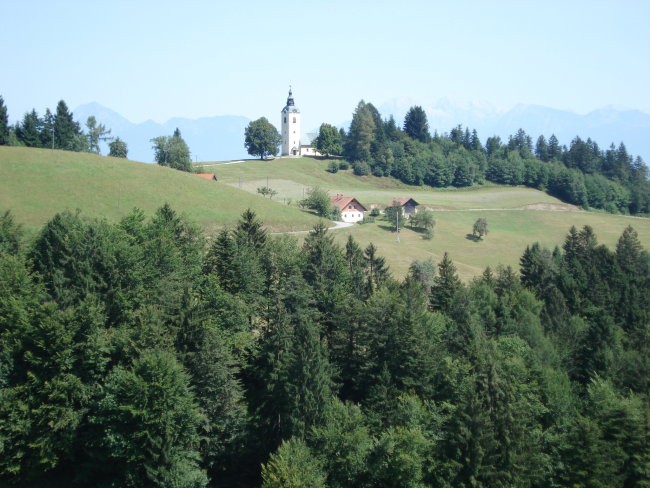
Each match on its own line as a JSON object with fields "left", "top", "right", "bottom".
{"left": 200, "top": 158, "right": 650, "bottom": 279}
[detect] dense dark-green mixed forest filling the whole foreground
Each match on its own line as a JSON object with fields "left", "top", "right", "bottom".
{"left": 0, "top": 208, "right": 650, "bottom": 488}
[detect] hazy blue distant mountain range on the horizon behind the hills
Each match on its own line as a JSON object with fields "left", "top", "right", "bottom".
{"left": 73, "top": 98, "right": 650, "bottom": 163}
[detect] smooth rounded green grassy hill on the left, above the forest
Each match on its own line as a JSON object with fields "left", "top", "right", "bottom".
{"left": 0, "top": 146, "right": 316, "bottom": 232}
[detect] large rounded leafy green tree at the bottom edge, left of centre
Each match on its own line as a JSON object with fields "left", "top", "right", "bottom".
{"left": 95, "top": 351, "right": 208, "bottom": 488}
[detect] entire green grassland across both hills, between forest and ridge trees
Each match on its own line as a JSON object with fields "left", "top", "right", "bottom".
{"left": 0, "top": 147, "right": 650, "bottom": 279}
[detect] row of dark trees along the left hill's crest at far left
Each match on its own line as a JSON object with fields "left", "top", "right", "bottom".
{"left": 0, "top": 96, "right": 128, "bottom": 158}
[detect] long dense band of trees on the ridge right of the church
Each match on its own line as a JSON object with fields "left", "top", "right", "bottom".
{"left": 315, "top": 101, "right": 650, "bottom": 214}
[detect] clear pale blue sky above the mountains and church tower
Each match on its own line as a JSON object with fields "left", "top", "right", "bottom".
{"left": 0, "top": 0, "right": 650, "bottom": 133}
